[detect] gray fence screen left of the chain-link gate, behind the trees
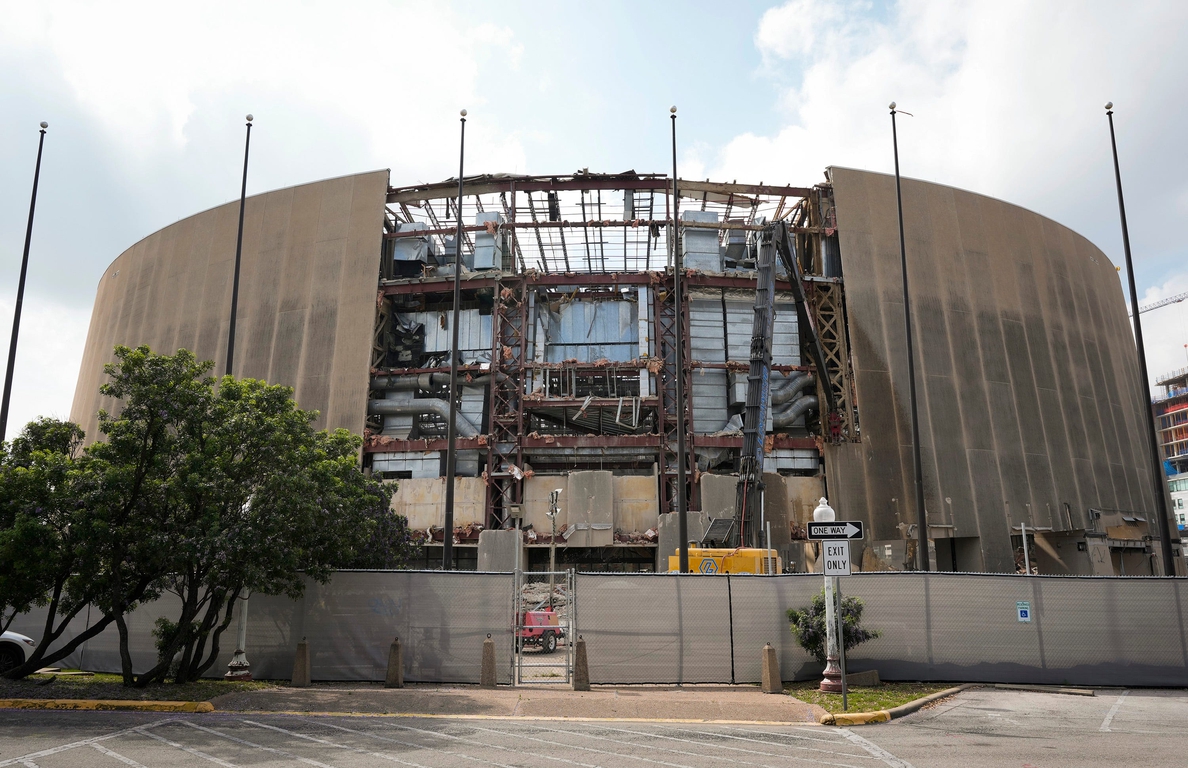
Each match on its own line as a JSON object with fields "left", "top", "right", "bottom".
{"left": 5, "top": 571, "right": 512, "bottom": 684}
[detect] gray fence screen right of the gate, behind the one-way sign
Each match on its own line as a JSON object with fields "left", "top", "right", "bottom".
{"left": 576, "top": 573, "right": 1188, "bottom": 686}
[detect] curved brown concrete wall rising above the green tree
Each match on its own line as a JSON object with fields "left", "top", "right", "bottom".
{"left": 70, "top": 170, "right": 388, "bottom": 440}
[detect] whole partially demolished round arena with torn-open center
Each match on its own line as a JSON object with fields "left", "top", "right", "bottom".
{"left": 72, "top": 168, "right": 1180, "bottom": 574}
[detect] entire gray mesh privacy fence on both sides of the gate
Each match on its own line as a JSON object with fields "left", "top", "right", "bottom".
{"left": 13, "top": 571, "right": 1188, "bottom": 686}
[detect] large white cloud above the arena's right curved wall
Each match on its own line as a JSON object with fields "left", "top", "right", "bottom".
{"left": 707, "top": 0, "right": 1188, "bottom": 394}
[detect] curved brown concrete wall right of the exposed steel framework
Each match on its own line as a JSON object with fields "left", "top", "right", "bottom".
{"left": 826, "top": 168, "right": 1159, "bottom": 571}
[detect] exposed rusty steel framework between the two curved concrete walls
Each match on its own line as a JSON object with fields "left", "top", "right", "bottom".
{"left": 365, "top": 172, "right": 857, "bottom": 525}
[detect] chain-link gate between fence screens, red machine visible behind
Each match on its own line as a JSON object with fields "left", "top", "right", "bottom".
{"left": 512, "top": 571, "right": 577, "bottom": 685}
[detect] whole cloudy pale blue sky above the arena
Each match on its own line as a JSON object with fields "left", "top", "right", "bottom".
{"left": 0, "top": 0, "right": 1188, "bottom": 435}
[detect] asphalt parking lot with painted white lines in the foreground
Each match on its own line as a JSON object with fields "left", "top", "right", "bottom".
{"left": 0, "top": 690, "right": 1188, "bottom": 768}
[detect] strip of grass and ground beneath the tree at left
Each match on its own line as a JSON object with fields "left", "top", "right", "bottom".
{"left": 0, "top": 671, "right": 278, "bottom": 701}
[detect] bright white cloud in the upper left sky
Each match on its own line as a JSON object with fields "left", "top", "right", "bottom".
{"left": 0, "top": 0, "right": 524, "bottom": 181}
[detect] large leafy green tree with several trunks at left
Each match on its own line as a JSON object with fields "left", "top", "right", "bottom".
{"left": 0, "top": 347, "right": 412, "bottom": 685}
